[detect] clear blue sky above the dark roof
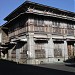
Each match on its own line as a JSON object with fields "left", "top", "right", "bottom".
{"left": 0, "top": 0, "right": 75, "bottom": 25}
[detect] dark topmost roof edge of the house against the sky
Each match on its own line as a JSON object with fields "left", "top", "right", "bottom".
{"left": 4, "top": 1, "right": 75, "bottom": 20}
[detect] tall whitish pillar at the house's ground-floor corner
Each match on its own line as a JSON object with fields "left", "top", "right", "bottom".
{"left": 27, "top": 33, "right": 35, "bottom": 59}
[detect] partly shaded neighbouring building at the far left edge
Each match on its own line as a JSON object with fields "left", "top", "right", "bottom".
{"left": 0, "top": 26, "right": 9, "bottom": 59}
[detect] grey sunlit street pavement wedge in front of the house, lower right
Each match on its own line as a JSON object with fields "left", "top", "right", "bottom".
{"left": 38, "top": 63, "right": 75, "bottom": 73}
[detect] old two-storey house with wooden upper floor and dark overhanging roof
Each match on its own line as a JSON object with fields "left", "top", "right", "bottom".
{"left": 3, "top": 1, "right": 75, "bottom": 64}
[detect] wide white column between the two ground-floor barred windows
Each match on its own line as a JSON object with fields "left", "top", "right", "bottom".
{"left": 45, "top": 38, "right": 54, "bottom": 63}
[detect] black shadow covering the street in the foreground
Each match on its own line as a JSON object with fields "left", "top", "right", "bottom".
{"left": 0, "top": 60, "right": 75, "bottom": 75}
